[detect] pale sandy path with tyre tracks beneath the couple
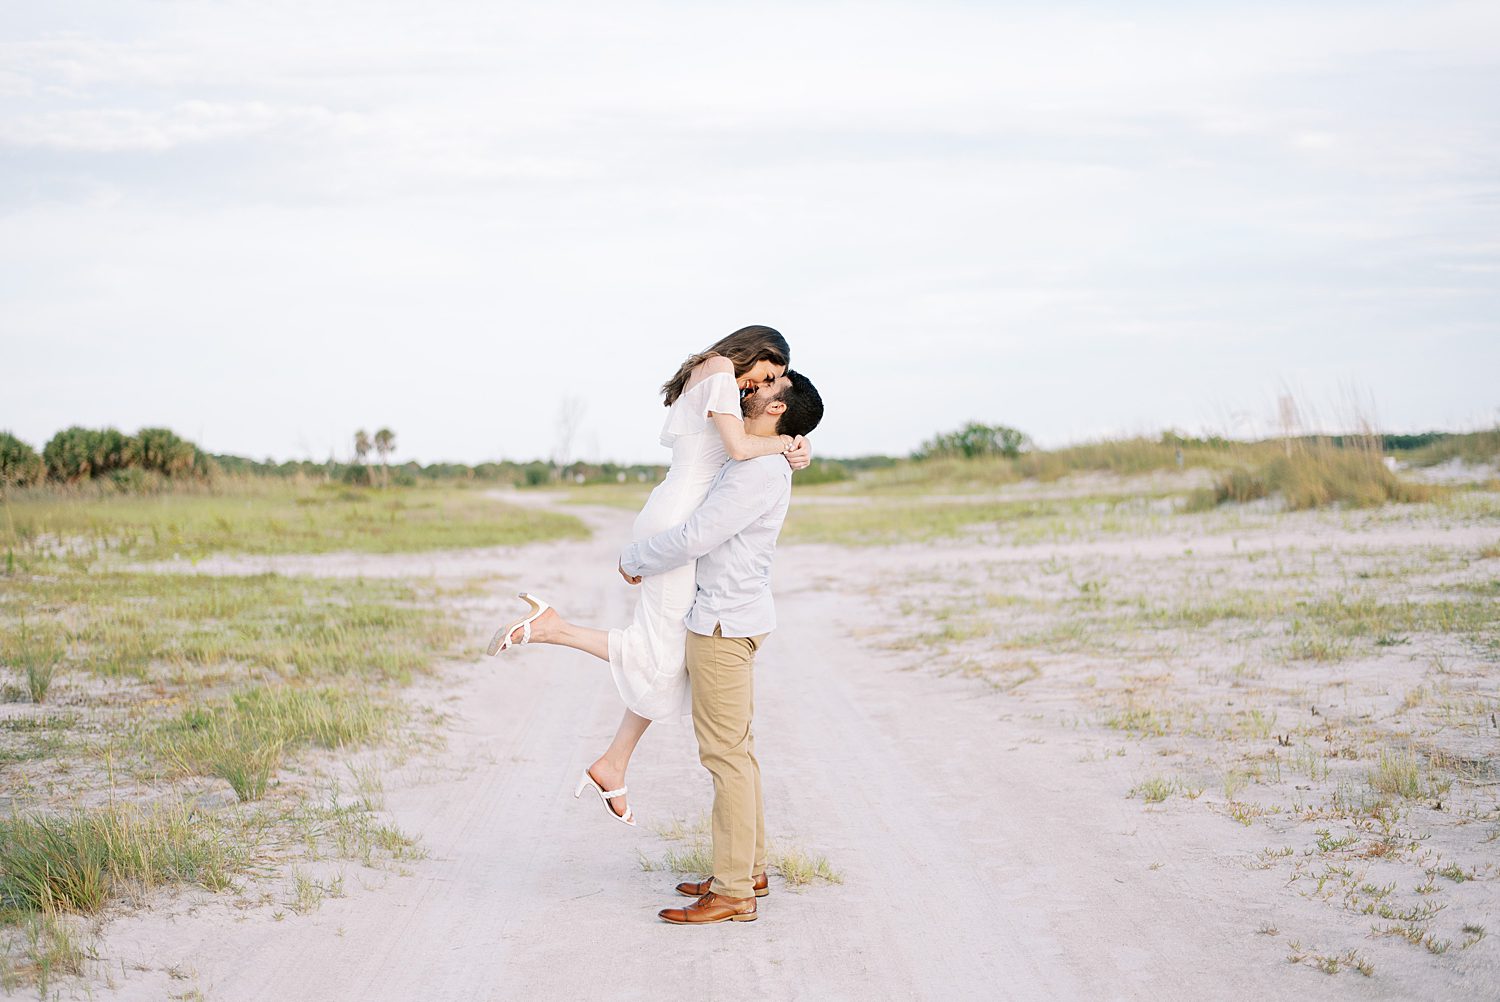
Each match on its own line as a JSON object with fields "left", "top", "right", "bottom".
{"left": 87, "top": 509, "right": 1446, "bottom": 1002}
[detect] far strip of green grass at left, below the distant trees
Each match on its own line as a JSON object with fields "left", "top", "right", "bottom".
{"left": 8, "top": 483, "right": 588, "bottom": 560}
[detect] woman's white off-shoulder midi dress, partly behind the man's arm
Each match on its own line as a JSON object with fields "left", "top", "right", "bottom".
{"left": 609, "top": 372, "right": 740, "bottom": 720}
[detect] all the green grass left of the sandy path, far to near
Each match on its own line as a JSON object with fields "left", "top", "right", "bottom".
{"left": 0, "top": 485, "right": 486, "bottom": 993}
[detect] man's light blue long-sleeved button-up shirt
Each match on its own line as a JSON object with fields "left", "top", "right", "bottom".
{"left": 620, "top": 455, "right": 792, "bottom": 636}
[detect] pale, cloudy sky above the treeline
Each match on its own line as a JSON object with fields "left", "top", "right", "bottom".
{"left": 0, "top": 0, "right": 1500, "bottom": 462}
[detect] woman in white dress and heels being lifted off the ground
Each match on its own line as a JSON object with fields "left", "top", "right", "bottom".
{"left": 489, "top": 324, "right": 812, "bottom": 825}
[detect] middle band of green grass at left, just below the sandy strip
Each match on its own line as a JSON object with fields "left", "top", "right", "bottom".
{"left": 0, "top": 572, "right": 461, "bottom": 681}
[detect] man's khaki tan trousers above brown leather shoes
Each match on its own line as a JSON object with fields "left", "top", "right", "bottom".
{"left": 687, "top": 627, "right": 765, "bottom": 897}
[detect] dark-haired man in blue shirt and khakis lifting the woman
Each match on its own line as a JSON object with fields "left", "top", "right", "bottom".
{"left": 620, "top": 371, "right": 824, "bottom": 926}
